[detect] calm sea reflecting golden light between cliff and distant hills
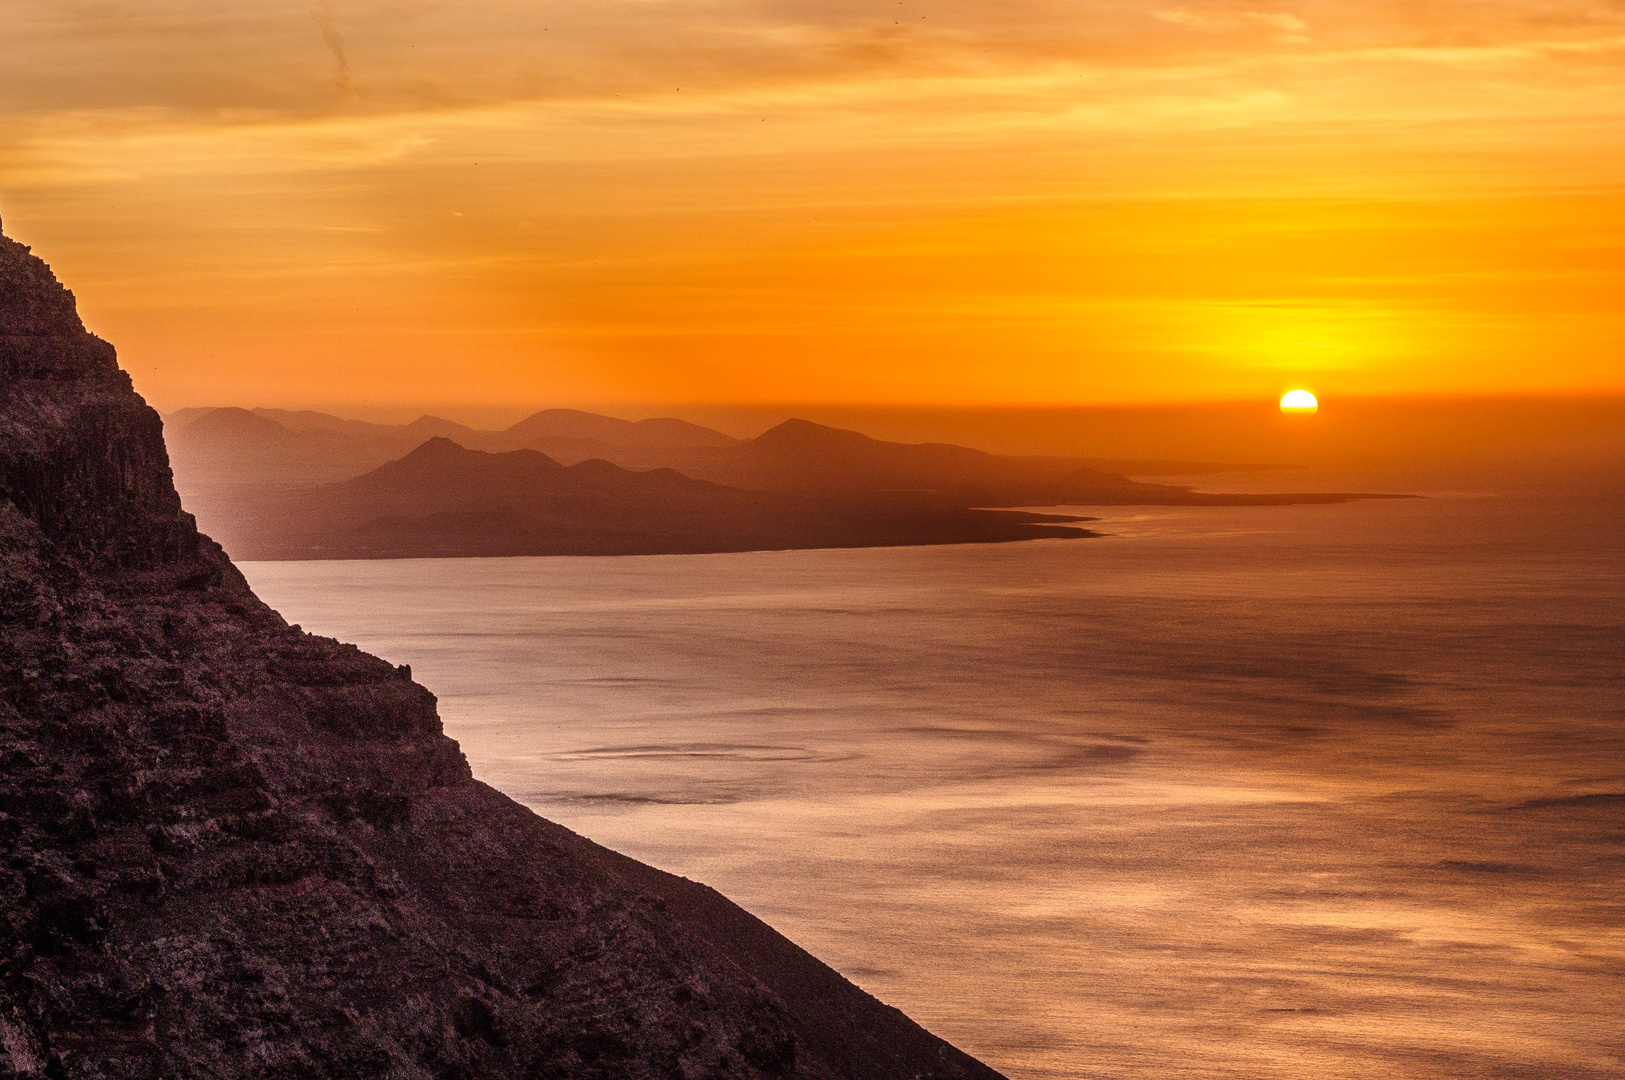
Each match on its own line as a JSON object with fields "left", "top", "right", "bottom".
{"left": 244, "top": 497, "right": 1625, "bottom": 1080}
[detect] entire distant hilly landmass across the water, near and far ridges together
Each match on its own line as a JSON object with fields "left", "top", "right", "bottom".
{"left": 166, "top": 408, "right": 1404, "bottom": 559}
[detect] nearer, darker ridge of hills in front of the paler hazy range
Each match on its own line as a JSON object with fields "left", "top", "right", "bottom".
{"left": 212, "top": 438, "right": 1090, "bottom": 559}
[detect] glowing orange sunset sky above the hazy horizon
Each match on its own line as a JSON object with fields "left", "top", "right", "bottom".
{"left": 0, "top": 0, "right": 1625, "bottom": 409}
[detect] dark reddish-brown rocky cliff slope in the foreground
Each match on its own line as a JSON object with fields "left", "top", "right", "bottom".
{"left": 0, "top": 220, "right": 996, "bottom": 1080}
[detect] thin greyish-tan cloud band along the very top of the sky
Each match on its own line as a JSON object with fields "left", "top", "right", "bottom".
{"left": 0, "top": 0, "right": 1625, "bottom": 123}
